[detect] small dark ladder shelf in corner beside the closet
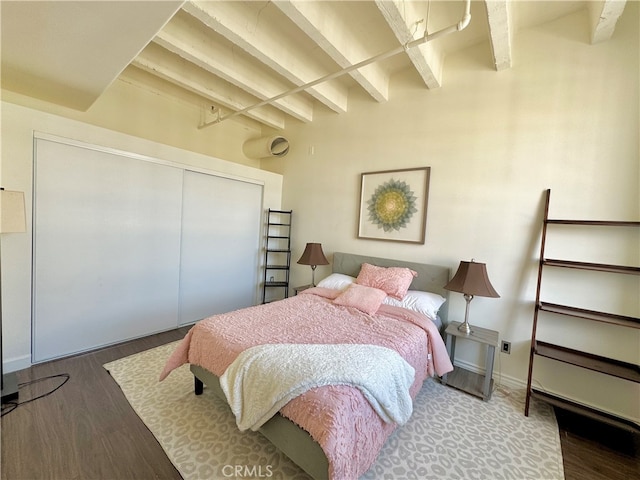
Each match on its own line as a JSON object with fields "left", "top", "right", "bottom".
{"left": 262, "top": 208, "right": 293, "bottom": 303}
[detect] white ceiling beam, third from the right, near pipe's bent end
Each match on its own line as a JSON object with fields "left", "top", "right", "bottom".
{"left": 376, "top": 0, "right": 443, "bottom": 88}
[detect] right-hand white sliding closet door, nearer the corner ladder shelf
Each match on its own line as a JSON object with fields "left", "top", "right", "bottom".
{"left": 179, "top": 171, "right": 263, "bottom": 325}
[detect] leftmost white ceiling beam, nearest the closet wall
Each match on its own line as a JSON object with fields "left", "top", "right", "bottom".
{"left": 132, "top": 45, "right": 285, "bottom": 130}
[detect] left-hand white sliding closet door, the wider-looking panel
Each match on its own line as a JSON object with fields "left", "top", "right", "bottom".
{"left": 32, "top": 138, "right": 183, "bottom": 362}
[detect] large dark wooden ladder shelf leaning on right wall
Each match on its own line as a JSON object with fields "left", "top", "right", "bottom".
{"left": 524, "top": 189, "right": 640, "bottom": 432}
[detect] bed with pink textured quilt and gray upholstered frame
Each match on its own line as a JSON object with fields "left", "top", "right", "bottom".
{"left": 162, "top": 252, "right": 452, "bottom": 480}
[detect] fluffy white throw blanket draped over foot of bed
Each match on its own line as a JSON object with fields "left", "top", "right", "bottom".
{"left": 220, "top": 344, "right": 415, "bottom": 430}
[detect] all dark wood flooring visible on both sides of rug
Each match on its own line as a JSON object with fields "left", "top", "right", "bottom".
{"left": 0, "top": 328, "right": 640, "bottom": 480}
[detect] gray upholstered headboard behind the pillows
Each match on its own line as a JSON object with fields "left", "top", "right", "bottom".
{"left": 332, "top": 252, "right": 450, "bottom": 325}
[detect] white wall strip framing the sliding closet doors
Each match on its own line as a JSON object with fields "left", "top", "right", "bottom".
{"left": 0, "top": 102, "right": 282, "bottom": 371}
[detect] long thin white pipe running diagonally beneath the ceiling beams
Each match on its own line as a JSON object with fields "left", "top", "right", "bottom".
{"left": 198, "top": 0, "right": 471, "bottom": 130}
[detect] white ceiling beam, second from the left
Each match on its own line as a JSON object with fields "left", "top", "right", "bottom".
{"left": 154, "top": 18, "right": 313, "bottom": 122}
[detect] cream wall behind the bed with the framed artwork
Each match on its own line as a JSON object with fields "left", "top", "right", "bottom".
{"left": 263, "top": 6, "right": 640, "bottom": 420}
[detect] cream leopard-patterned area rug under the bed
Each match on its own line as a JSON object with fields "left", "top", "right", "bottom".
{"left": 104, "top": 342, "right": 564, "bottom": 480}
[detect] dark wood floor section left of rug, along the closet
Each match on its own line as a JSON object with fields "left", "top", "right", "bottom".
{"left": 1, "top": 329, "right": 187, "bottom": 480}
